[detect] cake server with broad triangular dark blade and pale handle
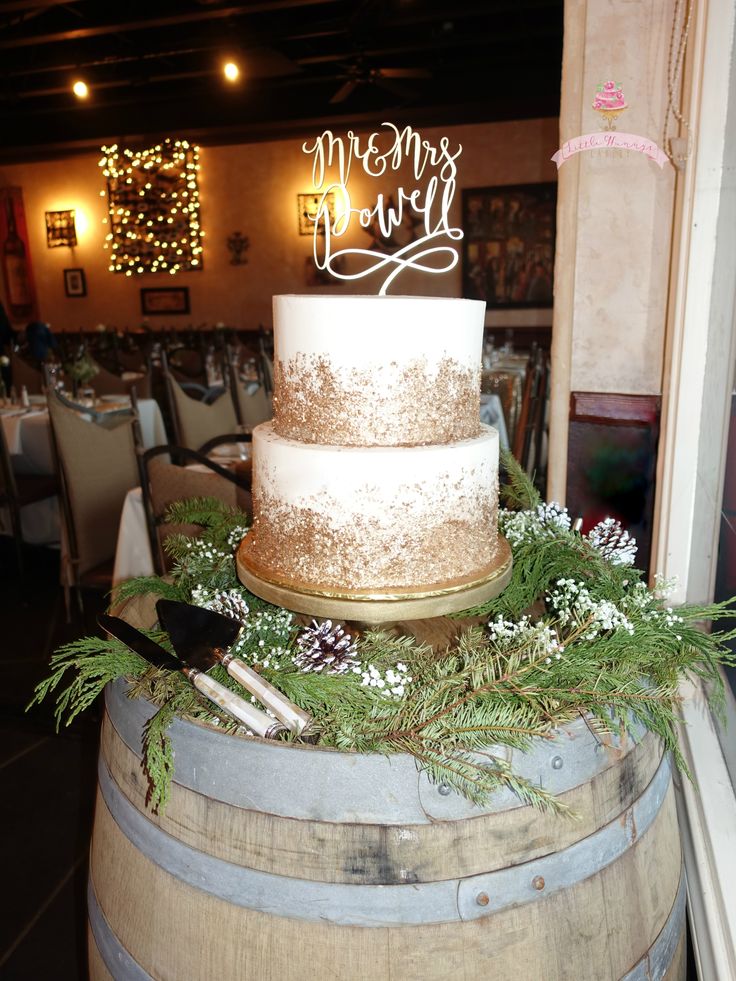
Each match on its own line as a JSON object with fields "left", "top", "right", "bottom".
{"left": 156, "top": 599, "right": 312, "bottom": 736}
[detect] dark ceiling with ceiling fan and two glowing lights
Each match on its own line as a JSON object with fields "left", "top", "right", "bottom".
{"left": 0, "top": 0, "right": 563, "bottom": 161}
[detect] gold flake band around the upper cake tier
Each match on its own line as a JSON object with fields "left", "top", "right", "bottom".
{"left": 274, "top": 354, "right": 480, "bottom": 446}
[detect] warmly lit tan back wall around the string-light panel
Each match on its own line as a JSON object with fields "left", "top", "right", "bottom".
{"left": 0, "top": 119, "right": 557, "bottom": 330}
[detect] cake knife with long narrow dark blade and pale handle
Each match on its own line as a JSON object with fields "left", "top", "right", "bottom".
{"left": 97, "top": 613, "right": 284, "bottom": 739}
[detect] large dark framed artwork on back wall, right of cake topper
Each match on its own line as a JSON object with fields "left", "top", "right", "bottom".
{"left": 462, "top": 182, "right": 557, "bottom": 309}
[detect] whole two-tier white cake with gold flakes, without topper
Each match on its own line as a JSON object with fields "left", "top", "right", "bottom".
{"left": 241, "top": 296, "right": 498, "bottom": 594}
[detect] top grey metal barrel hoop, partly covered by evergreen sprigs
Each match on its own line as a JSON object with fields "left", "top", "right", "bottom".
{"left": 106, "top": 682, "right": 645, "bottom": 825}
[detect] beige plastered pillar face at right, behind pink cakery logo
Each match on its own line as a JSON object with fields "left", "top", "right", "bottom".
{"left": 557, "top": 0, "right": 675, "bottom": 395}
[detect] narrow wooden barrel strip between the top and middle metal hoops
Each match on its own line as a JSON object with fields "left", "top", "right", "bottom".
{"left": 101, "top": 704, "right": 661, "bottom": 885}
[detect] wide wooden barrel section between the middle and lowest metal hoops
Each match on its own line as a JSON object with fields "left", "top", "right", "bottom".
{"left": 91, "top": 772, "right": 680, "bottom": 981}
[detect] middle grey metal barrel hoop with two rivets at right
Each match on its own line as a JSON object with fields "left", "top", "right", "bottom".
{"left": 99, "top": 757, "right": 671, "bottom": 927}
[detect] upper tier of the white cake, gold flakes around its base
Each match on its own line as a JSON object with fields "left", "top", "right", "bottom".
{"left": 273, "top": 294, "right": 485, "bottom": 446}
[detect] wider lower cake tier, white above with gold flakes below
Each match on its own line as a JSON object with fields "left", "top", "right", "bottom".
{"left": 241, "top": 423, "right": 499, "bottom": 593}
